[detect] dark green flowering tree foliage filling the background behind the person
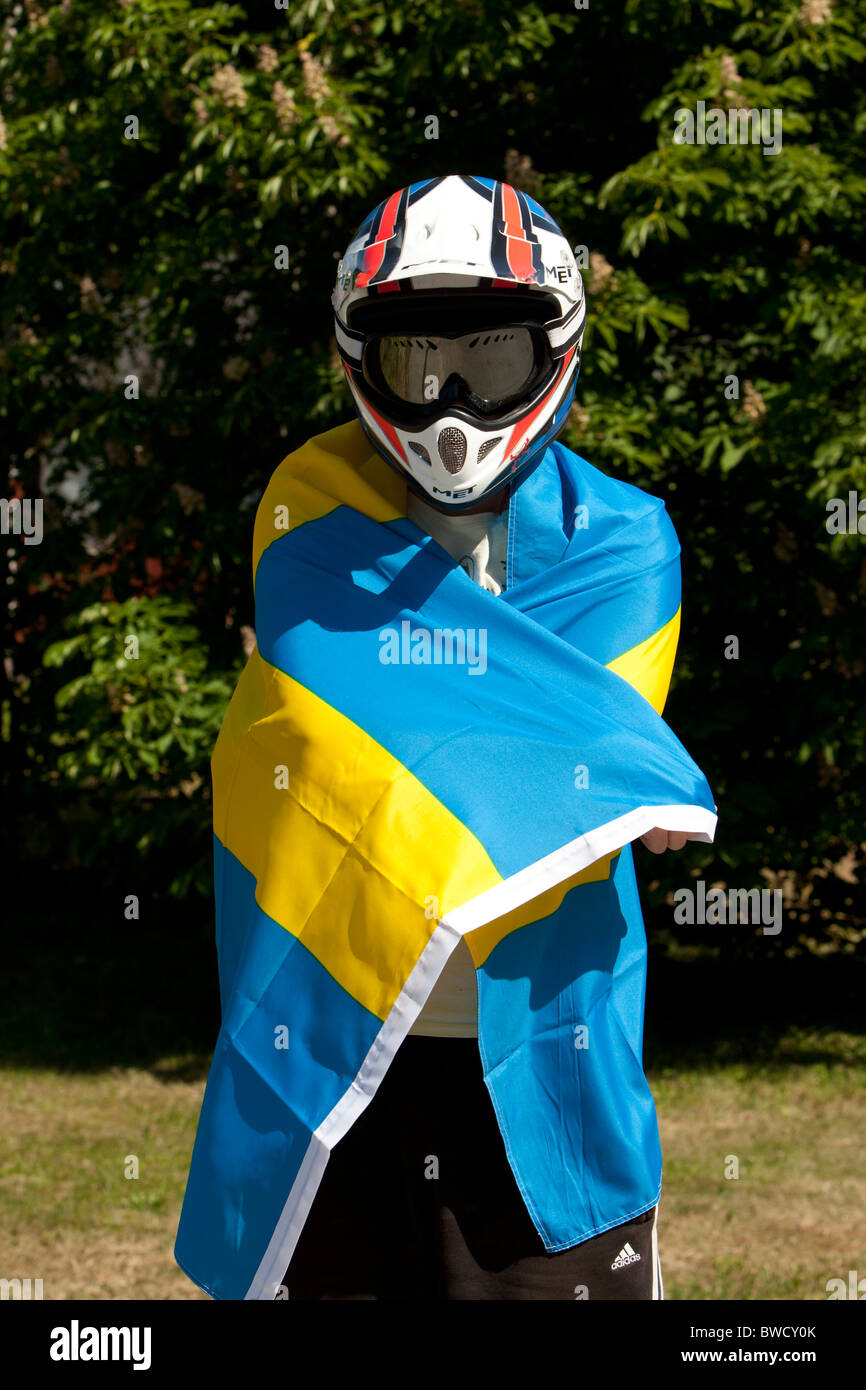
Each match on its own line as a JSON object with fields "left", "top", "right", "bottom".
{"left": 0, "top": 0, "right": 866, "bottom": 930}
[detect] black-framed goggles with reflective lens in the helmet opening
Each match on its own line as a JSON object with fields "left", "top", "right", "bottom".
{"left": 361, "top": 324, "right": 552, "bottom": 414}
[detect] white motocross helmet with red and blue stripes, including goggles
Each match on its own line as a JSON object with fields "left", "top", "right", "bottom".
{"left": 331, "top": 174, "right": 585, "bottom": 512}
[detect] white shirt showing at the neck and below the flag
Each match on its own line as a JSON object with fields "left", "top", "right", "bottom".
{"left": 407, "top": 492, "right": 509, "bottom": 1038}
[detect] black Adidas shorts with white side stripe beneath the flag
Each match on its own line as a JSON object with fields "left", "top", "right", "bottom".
{"left": 281, "top": 1036, "right": 664, "bottom": 1301}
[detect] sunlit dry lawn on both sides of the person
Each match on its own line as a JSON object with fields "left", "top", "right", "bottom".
{"left": 0, "top": 1027, "right": 866, "bottom": 1300}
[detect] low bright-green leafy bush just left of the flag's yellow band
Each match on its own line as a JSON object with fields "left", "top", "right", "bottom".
{"left": 43, "top": 598, "right": 240, "bottom": 897}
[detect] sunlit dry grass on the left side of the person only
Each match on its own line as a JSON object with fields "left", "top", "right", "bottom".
{"left": 0, "top": 1068, "right": 207, "bottom": 1300}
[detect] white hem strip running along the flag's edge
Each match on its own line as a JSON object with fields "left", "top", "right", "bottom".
{"left": 245, "top": 805, "right": 717, "bottom": 1302}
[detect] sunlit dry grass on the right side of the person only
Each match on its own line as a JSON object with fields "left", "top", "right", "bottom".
{"left": 649, "top": 1029, "right": 866, "bottom": 1301}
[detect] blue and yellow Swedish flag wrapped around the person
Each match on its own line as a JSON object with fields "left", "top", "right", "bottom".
{"left": 175, "top": 421, "right": 716, "bottom": 1300}
